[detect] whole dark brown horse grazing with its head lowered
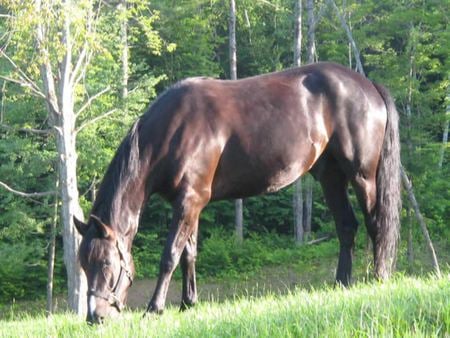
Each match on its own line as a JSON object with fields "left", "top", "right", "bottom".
{"left": 76, "top": 63, "right": 400, "bottom": 322}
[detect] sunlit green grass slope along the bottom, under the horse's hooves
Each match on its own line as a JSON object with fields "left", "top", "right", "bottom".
{"left": 0, "top": 275, "right": 450, "bottom": 337}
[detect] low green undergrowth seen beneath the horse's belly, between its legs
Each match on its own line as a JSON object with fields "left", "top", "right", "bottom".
{"left": 197, "top": 228, "right": 338, "bottom": 279}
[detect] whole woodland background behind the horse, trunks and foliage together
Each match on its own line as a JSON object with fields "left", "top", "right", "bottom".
{"left": 0, "top": 0, "right": 450, "bottom": 309}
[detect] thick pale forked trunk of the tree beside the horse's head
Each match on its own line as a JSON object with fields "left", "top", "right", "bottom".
{"left": 35, "top": 0, "right": 87, "bottom": 315}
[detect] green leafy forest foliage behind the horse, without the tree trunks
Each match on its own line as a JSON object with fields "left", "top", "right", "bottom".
{"left": 0, "top": 0, "right": 450, "bottom": 306}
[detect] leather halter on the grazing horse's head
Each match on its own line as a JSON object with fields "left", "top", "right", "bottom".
{"left": 87, "top": 237, "right": 133, "bottom": 312}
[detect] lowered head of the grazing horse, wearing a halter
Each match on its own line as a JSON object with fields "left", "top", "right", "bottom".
{"left": 74, "top": 215, "right": 134, "bottom": 323}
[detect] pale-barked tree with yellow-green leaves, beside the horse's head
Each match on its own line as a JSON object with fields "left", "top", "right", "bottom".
{"left": 1, "top": 0, "right": 163, "bottom": 314}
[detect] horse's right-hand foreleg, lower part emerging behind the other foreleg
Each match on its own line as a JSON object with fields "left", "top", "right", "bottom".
{"left": 180, "top": 230, "right": 197, "bottom": 311}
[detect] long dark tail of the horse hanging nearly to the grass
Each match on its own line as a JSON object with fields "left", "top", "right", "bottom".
{"left": 374, "top": 83, "right": 402, "bottom": 279}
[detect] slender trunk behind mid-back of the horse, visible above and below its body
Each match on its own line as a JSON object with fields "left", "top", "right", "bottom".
{"left": 228, "top": 0, "right": 244, "bottom": 242}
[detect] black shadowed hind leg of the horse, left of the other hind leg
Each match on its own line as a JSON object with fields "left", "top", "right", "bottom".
{"left": 319, "top": 160, "right": 358, "bottom": 286}
